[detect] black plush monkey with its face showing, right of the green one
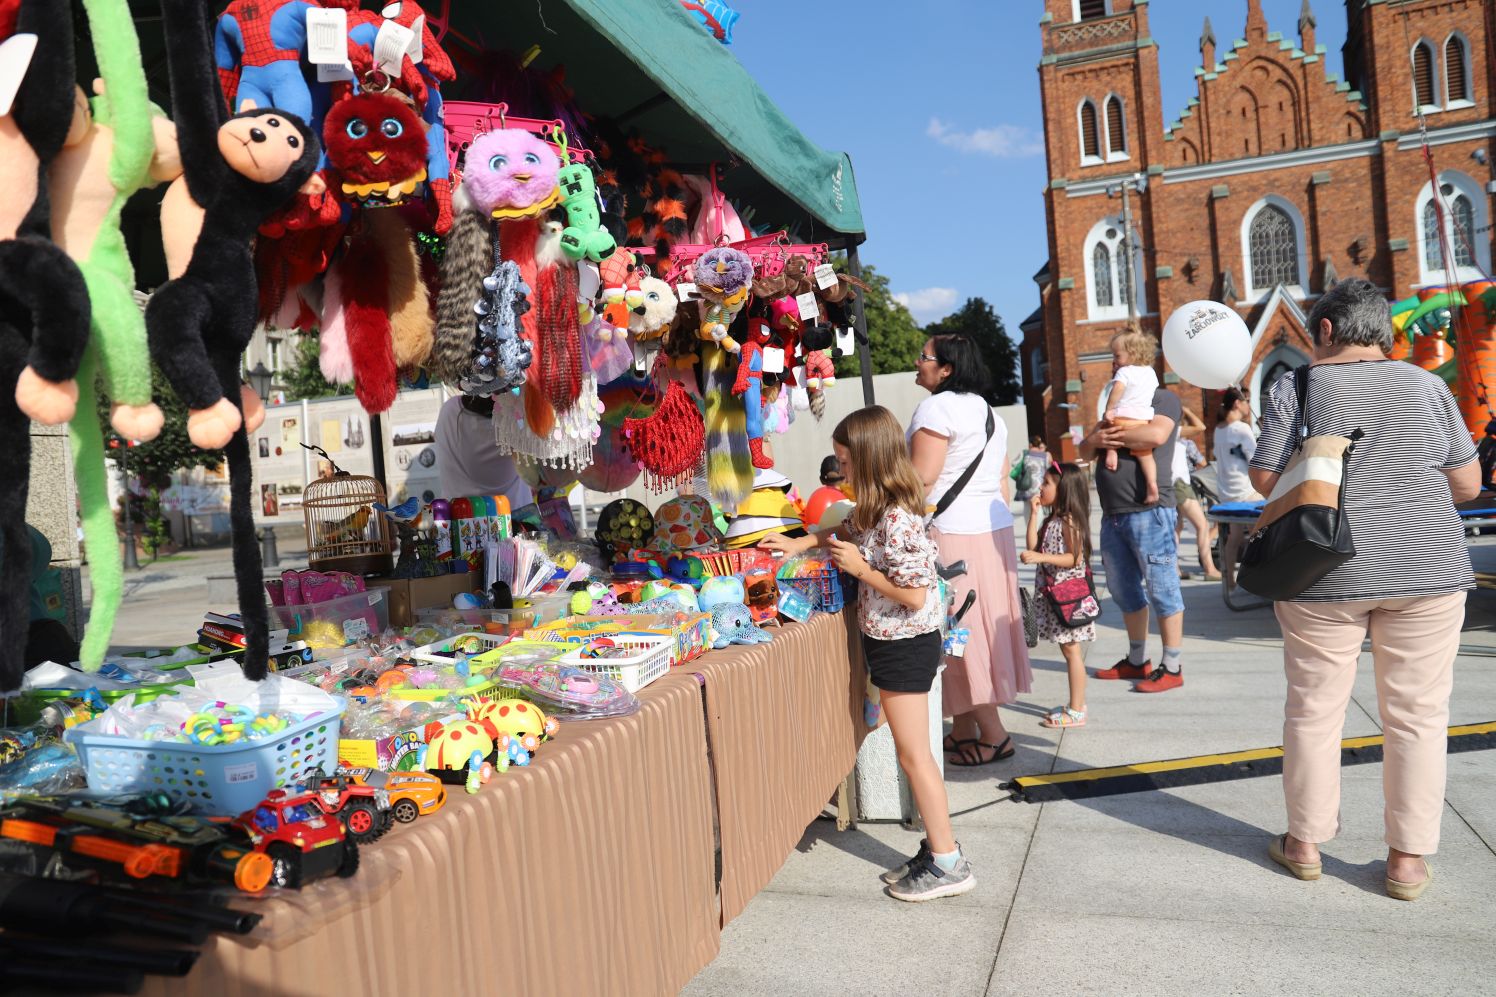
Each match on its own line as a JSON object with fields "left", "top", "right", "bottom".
{"left": 145, "top": 0, "right": 322, "bottom": 680}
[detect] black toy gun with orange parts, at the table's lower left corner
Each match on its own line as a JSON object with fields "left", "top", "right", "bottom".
{"left": 0, "top": 817, "right": 274, "bottom": 894}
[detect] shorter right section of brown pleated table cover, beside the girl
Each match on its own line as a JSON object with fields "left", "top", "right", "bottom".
{"left": 688, "top": 614, "right": 866, "bottom": 925}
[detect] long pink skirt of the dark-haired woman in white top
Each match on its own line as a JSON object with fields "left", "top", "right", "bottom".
{"left": 931, "top": 527, "right": 1034, "bottom": 717}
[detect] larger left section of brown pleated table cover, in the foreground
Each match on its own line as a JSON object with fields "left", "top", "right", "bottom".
{"left": 147, "top": 672, "right": 720, "bottom": 997}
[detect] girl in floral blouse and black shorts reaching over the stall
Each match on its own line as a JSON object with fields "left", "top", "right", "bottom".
{"left": 760, "top": 406, "right": 977, "bottom": 901}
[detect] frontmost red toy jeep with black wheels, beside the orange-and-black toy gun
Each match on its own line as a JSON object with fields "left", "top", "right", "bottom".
{"left": 230, "top": 789, "right": 359, "bottom": 889}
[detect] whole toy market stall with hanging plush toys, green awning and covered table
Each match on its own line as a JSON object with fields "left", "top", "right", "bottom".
{"left": 0, "top": 0, "right": 885, "bottom": 994}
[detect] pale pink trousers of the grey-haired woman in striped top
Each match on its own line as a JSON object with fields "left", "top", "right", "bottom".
{"left": 1275, "top": 591, "right": 1465, "bottom": 855}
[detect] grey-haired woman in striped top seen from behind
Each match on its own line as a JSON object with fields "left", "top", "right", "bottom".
{"left": 1251, "top": 278, "right": 1480, "bottom": 900}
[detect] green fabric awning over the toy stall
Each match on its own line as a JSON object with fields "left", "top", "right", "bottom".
{"left": 447, "top": 0, "right": 863, "bottom": 243}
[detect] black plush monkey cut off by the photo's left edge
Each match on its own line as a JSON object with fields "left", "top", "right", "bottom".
{"left": 0, "top": 0, "right": 88, "bottom": 692}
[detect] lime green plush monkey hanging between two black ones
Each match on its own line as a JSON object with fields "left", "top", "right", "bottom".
{"left": 48, "top": 0, "right": 181, "bottom": 671}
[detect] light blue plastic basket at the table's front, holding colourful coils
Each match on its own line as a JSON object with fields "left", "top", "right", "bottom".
{"left": 63, "top": 699, "right": 346, "bottom": 817}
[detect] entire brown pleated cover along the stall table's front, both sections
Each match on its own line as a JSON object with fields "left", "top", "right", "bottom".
{"left": 131, "top": 615, "right": 862, "bottom": 997}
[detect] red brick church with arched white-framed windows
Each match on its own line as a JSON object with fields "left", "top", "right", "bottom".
{"left": 1020, "top": 0, "right": 1496, "bottom": 454}
